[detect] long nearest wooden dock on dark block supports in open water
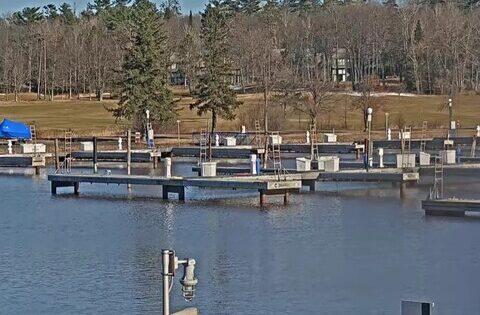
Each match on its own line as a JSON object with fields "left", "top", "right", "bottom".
{"left": 48, "top": 174, "right": 302, "bottom": 205}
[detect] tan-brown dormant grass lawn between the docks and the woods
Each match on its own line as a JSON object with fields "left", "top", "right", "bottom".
{"left": 0, "top": 91, "right": 480, "bottom": 136}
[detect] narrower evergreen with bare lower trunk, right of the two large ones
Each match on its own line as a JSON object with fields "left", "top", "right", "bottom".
{"left": 191, "top": 0, "right": 239, "bottom": 134}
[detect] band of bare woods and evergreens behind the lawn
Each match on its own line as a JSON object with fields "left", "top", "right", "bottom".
{"left": 0, "top": 0, "right": 480, "bottom": 131}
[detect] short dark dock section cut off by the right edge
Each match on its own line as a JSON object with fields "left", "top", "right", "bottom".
{"left": 422, "top": 198, "right": 480, "bottom": 216}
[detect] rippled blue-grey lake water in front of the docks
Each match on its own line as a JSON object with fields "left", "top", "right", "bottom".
{"left": 0, "top": 164, "right": 480, "bottom": 315}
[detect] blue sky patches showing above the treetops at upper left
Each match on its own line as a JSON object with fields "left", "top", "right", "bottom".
{"left": 0, "top": 0, "right": 207, "bottom": 14}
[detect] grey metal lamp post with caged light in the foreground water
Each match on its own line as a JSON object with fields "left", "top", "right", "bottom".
{"left": 162, "top": 249, "right": 198, "bottom": 315}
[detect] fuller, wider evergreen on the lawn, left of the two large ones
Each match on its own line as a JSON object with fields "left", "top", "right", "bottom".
{"left": 114, "top": 0, "right": 177, "bottom": 130}
